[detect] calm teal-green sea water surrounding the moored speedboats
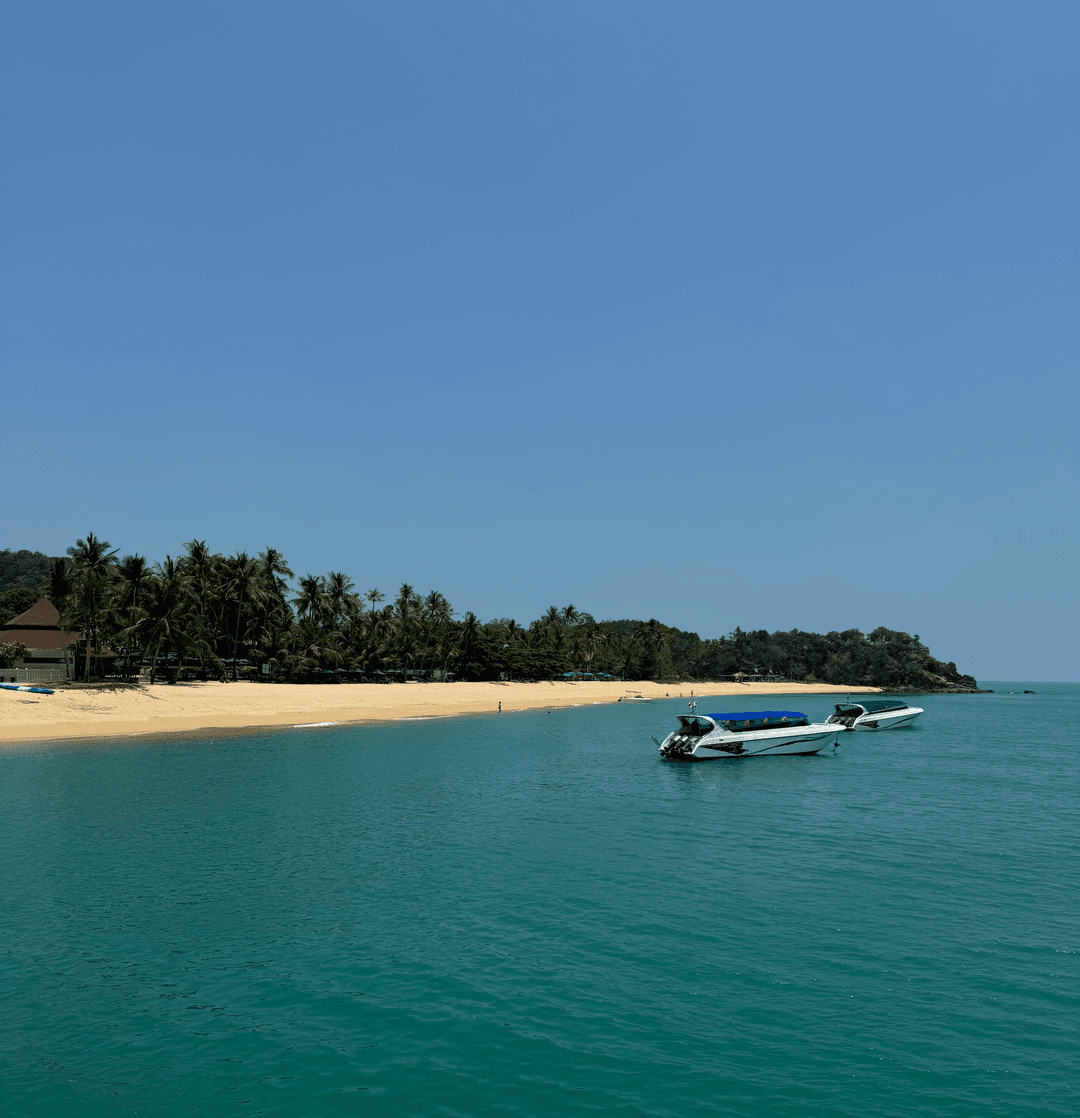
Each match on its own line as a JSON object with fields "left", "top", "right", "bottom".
{"left": 0, "top": 683, "right": 1080, "bottom": 1118}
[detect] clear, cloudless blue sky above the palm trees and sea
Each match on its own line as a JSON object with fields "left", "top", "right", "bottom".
{"left": 0, "top": 0, "right": 1080, "bottom": 680}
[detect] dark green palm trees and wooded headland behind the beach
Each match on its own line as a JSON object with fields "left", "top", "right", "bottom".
{"left": 0, "top": 534, "right": 979, "bottom": 693}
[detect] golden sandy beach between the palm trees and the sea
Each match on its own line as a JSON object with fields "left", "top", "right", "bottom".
{"left": 0, "top": 682, "right": 878, "bottom": 743}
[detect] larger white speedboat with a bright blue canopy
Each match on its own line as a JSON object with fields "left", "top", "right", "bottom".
{"left": 653, "top": 710, "right": 843, "bottom": 761}
